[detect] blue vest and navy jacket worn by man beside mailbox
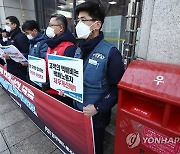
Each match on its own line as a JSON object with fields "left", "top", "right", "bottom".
{"left": 75, "top": 32, "right": 124, "bottom": 127}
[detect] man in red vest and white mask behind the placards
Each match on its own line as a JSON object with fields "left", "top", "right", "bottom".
{"left": 46, "top": 14, "right": 76, "bottom": 105}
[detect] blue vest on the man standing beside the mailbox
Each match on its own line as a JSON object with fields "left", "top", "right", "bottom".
{"left": 74, "top": 40, "right": 113, "bottom": 110}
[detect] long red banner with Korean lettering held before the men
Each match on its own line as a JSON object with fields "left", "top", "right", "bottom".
{"left": 0, "top": 65, "right": 94, "bottom": 154}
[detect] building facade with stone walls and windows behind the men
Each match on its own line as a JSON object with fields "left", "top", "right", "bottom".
{"left": 0, "top": 0, "right": 180, "bottom": 64}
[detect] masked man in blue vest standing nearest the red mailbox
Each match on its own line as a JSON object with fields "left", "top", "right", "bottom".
{"left": 73, "top": 1, "right": 124, "bottom": 154}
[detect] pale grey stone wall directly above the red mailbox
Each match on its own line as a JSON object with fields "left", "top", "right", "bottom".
{"left": 138, "top": 0, "right": 180, "bottom": 64}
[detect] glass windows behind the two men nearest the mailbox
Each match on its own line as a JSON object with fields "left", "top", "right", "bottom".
{"left": 44, "top": 0, "right": 129, "bottom": 50}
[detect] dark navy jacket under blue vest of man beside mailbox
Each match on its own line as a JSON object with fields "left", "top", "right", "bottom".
{"left": 75, "top": 32, "right": 124, "bottom": 128}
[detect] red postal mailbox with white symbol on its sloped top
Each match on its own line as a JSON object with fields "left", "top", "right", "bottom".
{"left": 114, "top": 60, "right": 180, "bottom": 154}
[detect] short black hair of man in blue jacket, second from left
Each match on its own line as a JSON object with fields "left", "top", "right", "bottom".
{"left": 22, "top": 20, "right": 40, "bottom": 32}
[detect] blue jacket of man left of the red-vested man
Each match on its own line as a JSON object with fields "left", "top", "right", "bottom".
{"left": 29, "top": 30, "right": 49, "bottom": 58}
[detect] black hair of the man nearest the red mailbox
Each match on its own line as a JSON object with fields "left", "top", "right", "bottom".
{"left": 76, "top": 1, "right": 105, "bottom": 24}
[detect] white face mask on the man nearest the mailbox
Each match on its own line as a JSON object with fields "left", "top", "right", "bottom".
{"left": 76, "top": 22, "right": 96, "bottom": 39}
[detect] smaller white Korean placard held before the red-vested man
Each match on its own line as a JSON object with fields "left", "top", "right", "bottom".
{"left": 28, "top": 56, "right": 46, "bottom": 86}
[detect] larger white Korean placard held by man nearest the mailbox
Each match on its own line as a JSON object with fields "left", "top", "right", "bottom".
{"left": 48, "top": 54, "right": 83, "bottom": 103}
